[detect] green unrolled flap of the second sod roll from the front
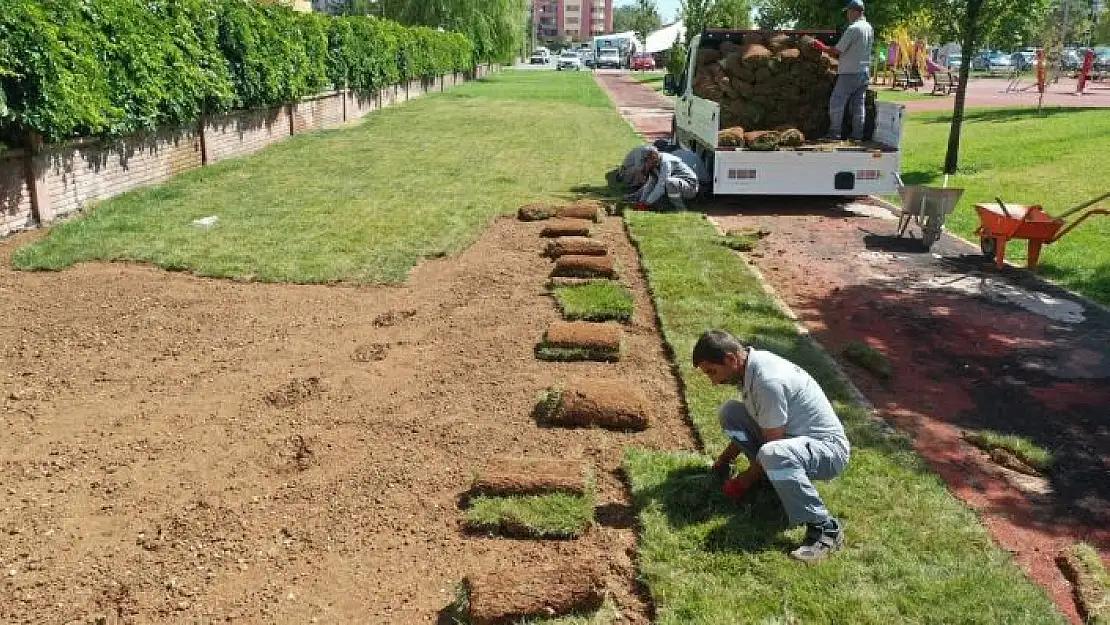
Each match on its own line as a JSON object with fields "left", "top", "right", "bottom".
{"left": 466, "top": 493, "right": 595, "bottom": 540}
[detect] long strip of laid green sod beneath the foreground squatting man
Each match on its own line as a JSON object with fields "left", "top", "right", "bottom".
{"left": 624, "top": 212, "right": 1066, "bottom": 625}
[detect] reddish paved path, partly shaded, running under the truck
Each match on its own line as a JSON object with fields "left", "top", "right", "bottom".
{"left": 597, "top": 69, "right": 1110, "bottom": 623}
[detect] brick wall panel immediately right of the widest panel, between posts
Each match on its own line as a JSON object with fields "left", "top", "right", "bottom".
{"left": 204, "top": 107, "right": 289, "bottom": 163}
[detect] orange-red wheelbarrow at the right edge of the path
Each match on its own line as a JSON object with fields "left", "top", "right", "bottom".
{"left": 975, "top": 193, "right": 1110, "bottom": 269}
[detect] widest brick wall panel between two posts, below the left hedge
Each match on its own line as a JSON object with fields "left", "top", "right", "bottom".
{"left": 41, "top": 128, "right": 201, "bottom": 218}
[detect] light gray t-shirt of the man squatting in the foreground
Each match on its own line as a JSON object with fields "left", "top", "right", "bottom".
{"left": 743, "top": 350, "right": 848, "bottom": 447}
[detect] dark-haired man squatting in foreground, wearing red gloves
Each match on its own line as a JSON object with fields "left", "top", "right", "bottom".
{"left": 693, "top": 330, "right": 850, "bottom": 564}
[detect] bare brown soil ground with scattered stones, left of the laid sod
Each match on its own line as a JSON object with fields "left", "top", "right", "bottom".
{"left": 0, "top": 218, "right": 695, "bottom": 624}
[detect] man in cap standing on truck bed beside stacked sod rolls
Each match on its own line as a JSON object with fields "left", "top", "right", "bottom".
{"left": 817, "top": 0, "right": 875, "bottom": 141}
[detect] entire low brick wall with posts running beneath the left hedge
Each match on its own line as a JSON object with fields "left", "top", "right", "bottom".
{"left": 0, "top": 65, "right": 492, "bottom": 238}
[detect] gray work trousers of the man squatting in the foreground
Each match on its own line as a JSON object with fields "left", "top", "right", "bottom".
{"left": 717, "top": 400, "right": 850, "bottom": 525}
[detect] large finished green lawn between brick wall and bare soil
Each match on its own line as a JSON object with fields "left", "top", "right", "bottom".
{"left": 13, "top": 72, "right": 636, "bottom": 283}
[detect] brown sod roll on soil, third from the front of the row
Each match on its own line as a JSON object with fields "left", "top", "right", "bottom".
{"left": 534, "top": 380, "right": 648, "bottom": 431}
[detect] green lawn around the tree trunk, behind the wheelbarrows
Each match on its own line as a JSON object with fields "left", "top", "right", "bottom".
{"left": 902, "top": 109, "right": 1110, "bottom": 304}
